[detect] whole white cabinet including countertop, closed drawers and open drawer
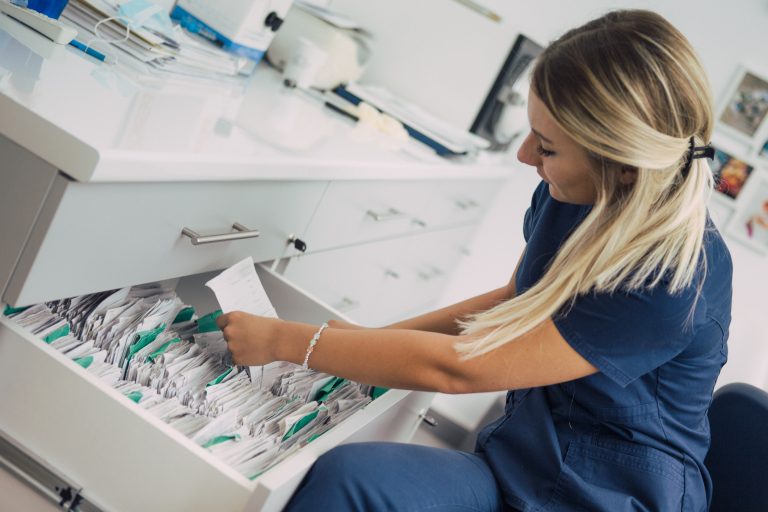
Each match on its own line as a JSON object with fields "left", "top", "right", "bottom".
{"left": 0, "top": 28, "right": 505, "bottom": 511}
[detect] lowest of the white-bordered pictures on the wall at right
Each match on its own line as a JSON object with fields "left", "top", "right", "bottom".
{"left": 727, "top": 172, "right": 768, "bottom": 254}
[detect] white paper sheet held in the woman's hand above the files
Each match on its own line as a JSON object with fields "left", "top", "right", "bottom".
{"left": 205, "top": 256, "right": 286, "bottom": 387}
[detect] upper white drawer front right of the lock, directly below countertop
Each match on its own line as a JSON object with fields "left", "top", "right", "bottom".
{"left": 304, "top": 180, "right": 501, "bottom": 252}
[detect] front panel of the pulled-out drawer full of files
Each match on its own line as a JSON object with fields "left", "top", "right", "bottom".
{"left": 0, "top": 318, "right": 253, "bottom": 511}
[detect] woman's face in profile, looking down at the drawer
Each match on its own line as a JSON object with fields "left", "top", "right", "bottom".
{"left": 517, "top": 90, "right": 597, "bottom": 204}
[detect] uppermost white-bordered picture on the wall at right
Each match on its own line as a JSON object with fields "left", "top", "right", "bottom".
{"left": 717, "top": 66, "right": 768, "bottom": 147}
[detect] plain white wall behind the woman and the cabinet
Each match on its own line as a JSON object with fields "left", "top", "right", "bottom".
{"left": 331, "top": 0, "right": 768, "bottom": 389}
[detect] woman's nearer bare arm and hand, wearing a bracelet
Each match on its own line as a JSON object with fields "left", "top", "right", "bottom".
{"left": 217, "top": 312, "right": 597, "bottom": 393}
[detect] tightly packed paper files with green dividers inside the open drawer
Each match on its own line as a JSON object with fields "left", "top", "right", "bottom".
{"left": 4, "top": 285, "right": 373, "bottom": 478}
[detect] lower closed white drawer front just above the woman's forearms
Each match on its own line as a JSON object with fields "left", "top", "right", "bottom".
{"left": 284, "top": 226, "right": 474, "bottom": 326}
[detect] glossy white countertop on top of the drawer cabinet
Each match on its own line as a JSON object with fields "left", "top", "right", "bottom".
{"left": 0, "top": 15, "right": 509, "bottom": 182}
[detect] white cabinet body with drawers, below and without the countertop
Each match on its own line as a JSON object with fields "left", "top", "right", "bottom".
{"left": 0, "top": 142, "right": 504, "bottom": 511}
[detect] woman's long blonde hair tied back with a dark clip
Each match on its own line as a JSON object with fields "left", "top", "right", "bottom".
{"left": 456, "top": 10, "right": 713, "bottom": 357}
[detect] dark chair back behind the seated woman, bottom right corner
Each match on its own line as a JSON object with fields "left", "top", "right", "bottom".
{"left": 704, "top": 383, "right": 768, "bottom": 512}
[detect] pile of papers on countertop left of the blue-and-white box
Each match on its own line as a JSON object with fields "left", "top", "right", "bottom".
{"left": 61, "top": 0, "right": 255, "bottom": 79}
